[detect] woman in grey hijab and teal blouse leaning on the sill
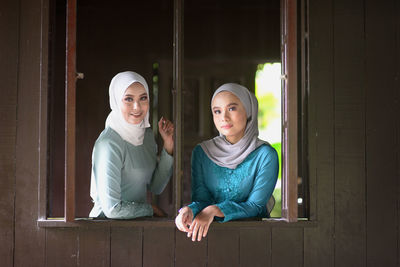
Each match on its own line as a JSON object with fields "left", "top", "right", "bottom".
{"left": 175, "top": 83, "right": 279, "bottom": 241}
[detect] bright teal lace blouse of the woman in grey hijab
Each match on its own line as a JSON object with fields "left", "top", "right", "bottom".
{"left": 189, "top": 144, "right": 279, "bottom": 222}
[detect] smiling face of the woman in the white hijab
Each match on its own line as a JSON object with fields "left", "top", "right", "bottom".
{"left": 121, "top": 82, "right": 149, "bottom": 124}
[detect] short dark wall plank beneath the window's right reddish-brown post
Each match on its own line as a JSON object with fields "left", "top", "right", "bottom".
{"left": 271, "top": 227, "right": 303, "bottom": 267}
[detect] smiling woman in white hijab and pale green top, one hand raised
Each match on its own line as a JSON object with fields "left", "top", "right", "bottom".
{"left": 89, "top": 71, "right": 174, "bottom": 219}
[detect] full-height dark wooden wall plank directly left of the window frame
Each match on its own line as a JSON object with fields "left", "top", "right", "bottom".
{"left": 14, "top": 0, "right": 48, "bottom": 266}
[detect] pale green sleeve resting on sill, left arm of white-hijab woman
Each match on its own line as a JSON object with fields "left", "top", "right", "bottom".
{"left": 92, "top": 138, "right": 153, "bottom": 219}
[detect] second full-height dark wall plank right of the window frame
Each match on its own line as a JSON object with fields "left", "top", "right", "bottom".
{"left": 334, "top": 0, "right": 366, "bottom": 266}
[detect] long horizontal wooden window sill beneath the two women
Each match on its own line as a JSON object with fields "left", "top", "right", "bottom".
{"left": 37, "top": 218, "right": 317, "bottom": 228}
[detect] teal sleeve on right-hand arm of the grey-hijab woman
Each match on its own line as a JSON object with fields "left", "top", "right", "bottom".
{"left": 217, "top": 147, "right": 279, "bottom": 222}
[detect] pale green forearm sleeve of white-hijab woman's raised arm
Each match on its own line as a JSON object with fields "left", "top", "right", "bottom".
{"left": 149, "top": 149, "right": 174, "bottom": 195}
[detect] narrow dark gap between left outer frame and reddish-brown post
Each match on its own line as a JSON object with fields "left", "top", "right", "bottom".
{"left": 46, "top": 0, "right": 67, "bottom": 217}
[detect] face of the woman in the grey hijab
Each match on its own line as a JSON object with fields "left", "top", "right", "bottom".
{"left": 211, "top": 91, "right": 247, "bottom": 144}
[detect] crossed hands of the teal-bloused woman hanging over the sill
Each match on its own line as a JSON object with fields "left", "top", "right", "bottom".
{"left": 175, "top": 205, "right": 224, "bottom": 241}
